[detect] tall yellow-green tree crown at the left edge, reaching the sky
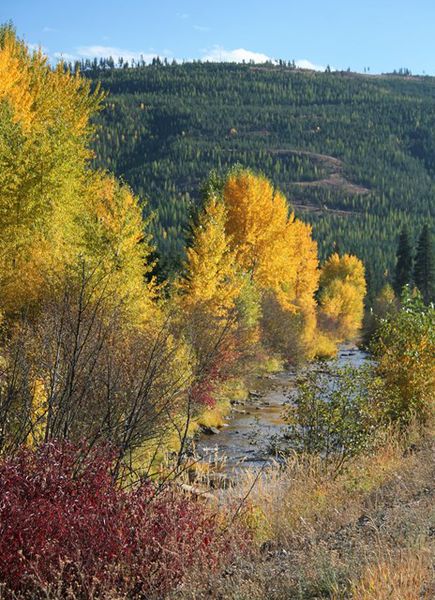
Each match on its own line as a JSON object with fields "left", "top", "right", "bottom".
{"left": 0, "top": 27, "right": 101, "bottom": 311}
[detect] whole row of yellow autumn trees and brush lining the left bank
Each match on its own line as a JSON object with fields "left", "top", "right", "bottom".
{"left": 0, "top": 27, "right": 365, "bottom": 460}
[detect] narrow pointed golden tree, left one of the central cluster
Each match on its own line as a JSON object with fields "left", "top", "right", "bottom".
{"left": 175, "top": 195, "right": 246, "bottom": 414}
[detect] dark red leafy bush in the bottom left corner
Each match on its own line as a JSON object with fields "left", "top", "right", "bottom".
{"left": 0, "top": 444, "right": 242, "bottom": 598}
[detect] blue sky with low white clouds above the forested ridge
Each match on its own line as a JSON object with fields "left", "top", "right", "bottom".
{"left": 0, "top": 0, "right": 435, "bottom": 75}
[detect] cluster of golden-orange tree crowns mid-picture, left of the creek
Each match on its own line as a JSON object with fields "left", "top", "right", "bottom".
{"left": 177, "top": 167, "right": 366, "bottom": 360}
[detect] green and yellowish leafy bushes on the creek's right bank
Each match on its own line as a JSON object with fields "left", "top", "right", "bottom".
{"left": 271, "top": 289, "right": 435, "bottom": 472}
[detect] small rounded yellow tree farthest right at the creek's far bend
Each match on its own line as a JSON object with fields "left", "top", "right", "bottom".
{"left": 319, "top": 254, "right": 366, "bottom": 340}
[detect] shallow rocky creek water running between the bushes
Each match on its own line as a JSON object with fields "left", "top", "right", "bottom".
{"left": 196, "top": 345, "right": 367, "bottom": 474}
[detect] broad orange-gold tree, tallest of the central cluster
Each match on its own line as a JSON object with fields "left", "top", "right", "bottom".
{"left": 223, "top": 169, "right": 319, "bottom": 356}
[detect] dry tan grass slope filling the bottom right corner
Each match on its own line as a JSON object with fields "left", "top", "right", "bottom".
{"left": 176, "top": 428, "right": 435, "bottom": 600}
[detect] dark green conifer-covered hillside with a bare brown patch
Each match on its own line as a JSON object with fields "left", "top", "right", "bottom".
{"left": 81, "top": 61, "right": 435, "bottom": 292}
